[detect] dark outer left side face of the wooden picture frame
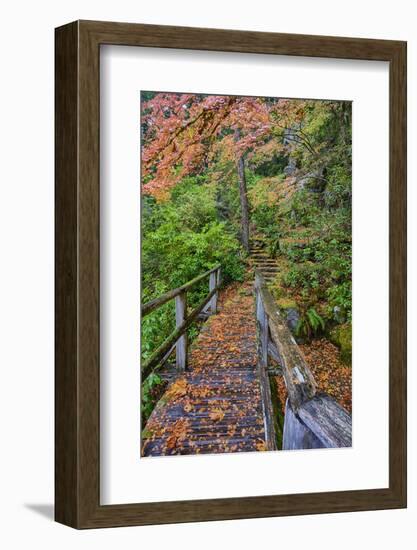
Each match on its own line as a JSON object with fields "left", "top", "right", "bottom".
{"left": 55, "top": 23, "right": 80, "bottom": 525}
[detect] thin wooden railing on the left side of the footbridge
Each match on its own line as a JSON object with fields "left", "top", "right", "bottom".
{"left": 141, "top": 265, "right": 220, "bottom": 380}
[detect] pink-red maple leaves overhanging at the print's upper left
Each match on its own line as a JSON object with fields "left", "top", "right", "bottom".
{"left": 142, "top": 93, "right": 304, "bottom": 199}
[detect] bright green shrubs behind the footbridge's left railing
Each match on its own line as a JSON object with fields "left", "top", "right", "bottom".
{"left": 141, "top": 177, "right": 244, "bottom": 370}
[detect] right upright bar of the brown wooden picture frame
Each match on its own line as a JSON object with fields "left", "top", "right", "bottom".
{"left": 389, "top": 38, "right": 407, "bottom": 506}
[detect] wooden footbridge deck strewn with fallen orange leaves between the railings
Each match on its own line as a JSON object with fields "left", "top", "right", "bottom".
{"left": 142, "top": 282, "right": 266, "bottom": 456}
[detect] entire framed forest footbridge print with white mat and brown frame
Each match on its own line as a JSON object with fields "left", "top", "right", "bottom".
{"left": 55, "top": 21, "right": 406, "bottom": 528}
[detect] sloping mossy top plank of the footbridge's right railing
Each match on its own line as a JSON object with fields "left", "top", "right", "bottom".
{"left": 255, "top": 271, "right": 316, "bottom": 411}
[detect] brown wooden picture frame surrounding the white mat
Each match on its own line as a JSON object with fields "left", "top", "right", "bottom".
{"left": 55, "top": 21, "right": 407, "bottom": 528}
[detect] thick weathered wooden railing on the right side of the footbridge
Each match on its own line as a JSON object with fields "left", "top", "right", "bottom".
{"left": 255, "top": 270, "right": 352, "bottom": 450}
